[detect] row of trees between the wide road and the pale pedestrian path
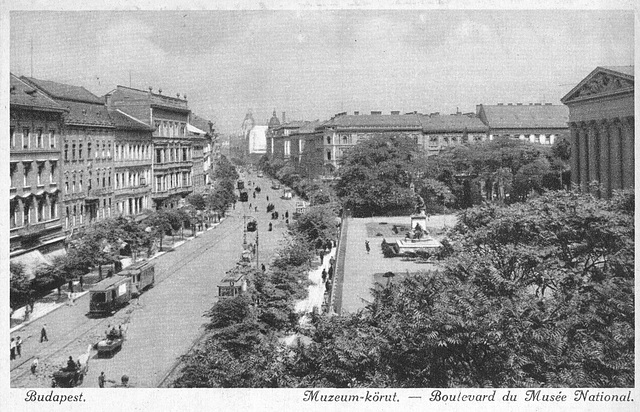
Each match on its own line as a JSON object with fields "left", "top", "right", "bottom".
{"left": 174, "top": 200, "right": 337, "bottom": 387}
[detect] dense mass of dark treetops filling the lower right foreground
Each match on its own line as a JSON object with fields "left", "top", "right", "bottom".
{"left": 176, "top": 191, "right": 635, "bottom": 388}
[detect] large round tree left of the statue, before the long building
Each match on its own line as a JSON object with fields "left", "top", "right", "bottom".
{"left": 336, "top": 135, "right": 422, "bottom": 216}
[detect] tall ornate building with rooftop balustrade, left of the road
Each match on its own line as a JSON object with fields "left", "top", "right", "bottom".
{"left": 105, "top": 86, "right": 193, "bottom": 209}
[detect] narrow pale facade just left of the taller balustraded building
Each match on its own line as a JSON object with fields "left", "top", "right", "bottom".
{"left": 109, "top": 109, "right": 153, "bottom": 216}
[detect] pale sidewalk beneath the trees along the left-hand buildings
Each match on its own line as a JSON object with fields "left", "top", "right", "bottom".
{"left": 9, "top": 218, "right": 225, "bottom": 333}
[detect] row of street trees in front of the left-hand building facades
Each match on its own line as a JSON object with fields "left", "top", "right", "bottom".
{"left": 10, "top": 156, "right": 238, "bottom": 308}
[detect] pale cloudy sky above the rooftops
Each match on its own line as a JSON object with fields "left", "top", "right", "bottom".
{"left": 10, "top": 10, "right": 634, "bottom": 132}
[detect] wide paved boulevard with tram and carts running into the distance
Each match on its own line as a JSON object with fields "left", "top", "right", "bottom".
{"left": 11, "top": 177, "right": 294, "bottom": 387}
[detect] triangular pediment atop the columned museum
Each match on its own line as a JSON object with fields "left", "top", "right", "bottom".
{"left": 561, "top": 67, "right": 633, "bottom": 103}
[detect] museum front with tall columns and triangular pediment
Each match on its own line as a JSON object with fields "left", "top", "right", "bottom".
{"left": 562, "top": 66, "right": 635, "bottom": 198}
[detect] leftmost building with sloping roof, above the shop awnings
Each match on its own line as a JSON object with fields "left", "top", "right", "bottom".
{"left": 9, "top": 74, "right": 67, "bottom": 257}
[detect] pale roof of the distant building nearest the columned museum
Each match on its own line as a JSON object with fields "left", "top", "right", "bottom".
{"left": 478, "top": 104, "right": 569, "bottom": 129}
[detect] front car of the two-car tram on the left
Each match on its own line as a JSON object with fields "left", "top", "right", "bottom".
{"left": 89, "top": 276, "right": 133, "bottom": 315}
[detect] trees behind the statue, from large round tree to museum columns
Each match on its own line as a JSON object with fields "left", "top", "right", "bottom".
{"left": 336, "top": 135, "right": 570, "bottom": 216}
